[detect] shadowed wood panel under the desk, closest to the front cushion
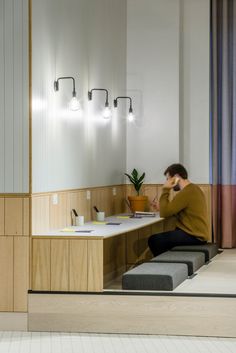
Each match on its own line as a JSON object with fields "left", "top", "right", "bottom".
{"left": 103, "top": 234, "right": 126, "bottom": 288}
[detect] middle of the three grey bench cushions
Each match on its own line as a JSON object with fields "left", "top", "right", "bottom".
{"left": 151, "top": 251, "right": 205, "bottom": 276}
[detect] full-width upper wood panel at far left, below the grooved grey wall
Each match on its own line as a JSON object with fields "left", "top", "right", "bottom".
{"left": 5, "top": 197, "right": 23, "bottom": 235}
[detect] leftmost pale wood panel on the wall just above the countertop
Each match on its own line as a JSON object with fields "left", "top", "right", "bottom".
{"left": 32, "top": 195, "right": 49, "bottom": 234}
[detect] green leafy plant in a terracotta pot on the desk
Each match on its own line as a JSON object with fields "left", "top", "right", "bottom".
{"left": 125, "top": 168, "right": 148, "bottom": 212}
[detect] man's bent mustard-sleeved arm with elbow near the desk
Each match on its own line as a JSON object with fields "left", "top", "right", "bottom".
{"left": 159, "top": 188, "right": 188, "bottom": 217}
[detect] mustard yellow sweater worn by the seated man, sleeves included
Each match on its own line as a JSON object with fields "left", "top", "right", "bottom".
{"left": 160, "top": 183, "right": 209, "bottom": 240}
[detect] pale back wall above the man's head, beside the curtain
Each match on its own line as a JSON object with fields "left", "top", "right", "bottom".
{"left": 127, "top": 0, "right": 210, "bottom": 183}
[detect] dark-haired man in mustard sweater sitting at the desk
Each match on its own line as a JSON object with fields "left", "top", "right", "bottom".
{"left": 148, "top": 164, "right": 209, "bottom": 256}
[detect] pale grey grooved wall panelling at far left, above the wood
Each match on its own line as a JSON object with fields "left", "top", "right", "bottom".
{"left": 0, "top": 0, "right": 29, "bottom": 193}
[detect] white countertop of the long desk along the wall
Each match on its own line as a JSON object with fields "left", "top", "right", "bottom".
{"left": 33, "top": 213, "right": 163, "bottom": 239}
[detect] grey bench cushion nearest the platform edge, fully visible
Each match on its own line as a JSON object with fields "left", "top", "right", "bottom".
{"left": 122, "top": 262, "right": 188, "bottom": 291}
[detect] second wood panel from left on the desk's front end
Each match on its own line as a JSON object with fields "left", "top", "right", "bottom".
{"left": 51, "top": 239, "right": 69, "bottom": 291}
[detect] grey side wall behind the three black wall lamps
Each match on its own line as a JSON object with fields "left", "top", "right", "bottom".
{"left": 32, "top": 0, "right": 126, "bottom": 192}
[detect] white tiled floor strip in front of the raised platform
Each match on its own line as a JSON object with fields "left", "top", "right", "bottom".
{"left": 0, "top": 332, "right": 236, "bottom": 353}
